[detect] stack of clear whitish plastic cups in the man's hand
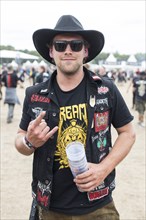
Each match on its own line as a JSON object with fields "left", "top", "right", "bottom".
{"left": 66, "top": 141, "right": 88, "bottom": 177}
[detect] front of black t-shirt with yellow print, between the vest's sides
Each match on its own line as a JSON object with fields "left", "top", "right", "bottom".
{"left": 50, "top": 78, "right": 92, "bottom": 213}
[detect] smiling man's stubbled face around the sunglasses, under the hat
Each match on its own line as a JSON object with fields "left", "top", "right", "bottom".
{"left": 50, "top": 34, "right": 88, "bottom": 75}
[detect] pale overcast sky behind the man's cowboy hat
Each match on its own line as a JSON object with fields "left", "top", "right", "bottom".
{"left": 0, "top": 0, "right": 146, "bottom": 54}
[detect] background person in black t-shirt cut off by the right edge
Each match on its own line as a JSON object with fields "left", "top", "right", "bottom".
{"left": 134, "top": 71, "right": 146, "bottom": 127}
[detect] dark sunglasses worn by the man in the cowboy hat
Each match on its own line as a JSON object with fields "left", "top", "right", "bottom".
{"left": 53, "top": 40, "right": 85, "bottom": 52}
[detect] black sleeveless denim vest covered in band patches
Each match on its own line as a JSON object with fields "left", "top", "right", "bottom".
{"left": 26, "top": 69, "right": 115, "bottom": 210}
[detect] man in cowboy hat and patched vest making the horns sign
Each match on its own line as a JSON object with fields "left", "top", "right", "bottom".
{"left": 15, "top": 15, "right": 135, "bottom": 220}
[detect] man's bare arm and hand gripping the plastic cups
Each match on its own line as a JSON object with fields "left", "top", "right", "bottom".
{"left": 74, "top": 123, "right": 135, "bottom": 191}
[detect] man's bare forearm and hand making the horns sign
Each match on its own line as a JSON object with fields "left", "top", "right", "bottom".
{"left": 15, "top": 112, "right": 58, "bottom": 155}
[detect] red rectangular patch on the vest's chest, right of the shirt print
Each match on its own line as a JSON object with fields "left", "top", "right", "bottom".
{"left": 94, "top": 111, "right": 109, "bottom": 132}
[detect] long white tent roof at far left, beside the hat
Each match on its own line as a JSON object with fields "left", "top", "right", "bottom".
{"left": 0, "top": 50, "right": 39, "bottom": 60}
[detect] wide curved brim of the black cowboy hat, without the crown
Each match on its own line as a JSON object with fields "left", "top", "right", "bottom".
{"left": 33, "top": 29, "right": 104, "bottom": 64}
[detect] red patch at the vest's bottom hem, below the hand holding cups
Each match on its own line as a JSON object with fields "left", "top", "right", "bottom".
{"left": 87, "top": 187, "right": 109, "bottom": 202}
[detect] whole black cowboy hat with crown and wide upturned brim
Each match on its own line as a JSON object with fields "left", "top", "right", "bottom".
{"left": 33, "top": 15, "right": 104, "bottom": 64}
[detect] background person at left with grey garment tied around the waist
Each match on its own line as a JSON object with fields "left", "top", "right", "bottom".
{"left": 2, "top": 64, "right": 20, "bottom": 123}
